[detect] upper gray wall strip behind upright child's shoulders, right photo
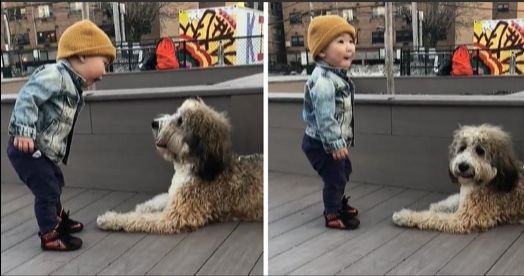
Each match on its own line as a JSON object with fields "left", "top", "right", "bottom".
{"left": 269, "top": 76, "right": 524, "bottom": 95}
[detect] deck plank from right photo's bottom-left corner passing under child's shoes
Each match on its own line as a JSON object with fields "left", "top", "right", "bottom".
{"left": 269, "top": 190, "right": 428, "bottom": 275}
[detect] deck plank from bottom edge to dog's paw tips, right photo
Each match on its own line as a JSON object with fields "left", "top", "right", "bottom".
{"left": 291, "top": 190, "right": 434, "bottom": 275}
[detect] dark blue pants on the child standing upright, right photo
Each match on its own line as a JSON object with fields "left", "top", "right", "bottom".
{"left": 302, "top": 134, "right": 352, "bottom": 214}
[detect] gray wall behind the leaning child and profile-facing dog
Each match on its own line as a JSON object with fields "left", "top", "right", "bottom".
{"left": 0, "top": 85, "right": 264, "bottom": 192}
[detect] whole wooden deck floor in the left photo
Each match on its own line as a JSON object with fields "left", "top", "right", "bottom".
{"left": 1, "top": 183, "right": 263, "bottom": 275}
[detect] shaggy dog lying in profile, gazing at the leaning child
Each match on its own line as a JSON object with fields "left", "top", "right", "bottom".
{"left": 96, "top": 99, "right": 263, "bottom": 234}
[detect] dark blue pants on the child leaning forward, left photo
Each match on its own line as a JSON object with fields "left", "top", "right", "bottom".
{"left": 7, "top": 138, "right": 64, "bottom": 233}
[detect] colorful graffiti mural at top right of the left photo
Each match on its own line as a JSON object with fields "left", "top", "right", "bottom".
{"left": 178, "top": 5, "right": 264, "bottom": 67}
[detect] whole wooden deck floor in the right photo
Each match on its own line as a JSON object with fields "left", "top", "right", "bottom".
{"left": 268, "top": 171, "right": 524, "bottom": 275}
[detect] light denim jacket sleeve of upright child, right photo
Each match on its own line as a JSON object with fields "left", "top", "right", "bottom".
{"left": 310, "top": 77, "right": 346, "bottom": 153}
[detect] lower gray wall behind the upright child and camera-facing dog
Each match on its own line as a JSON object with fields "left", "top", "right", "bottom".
{"left": 268, "top": 93, "right": 524, "bottom": 192}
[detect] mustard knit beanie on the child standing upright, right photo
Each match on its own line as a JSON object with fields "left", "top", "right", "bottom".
{"left": 307, "top": 15, "right": 356, "bottom": 60}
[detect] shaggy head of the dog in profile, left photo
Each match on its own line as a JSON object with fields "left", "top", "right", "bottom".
{"left": 152, "top": 99, "right": 231, "bottom": 181}
